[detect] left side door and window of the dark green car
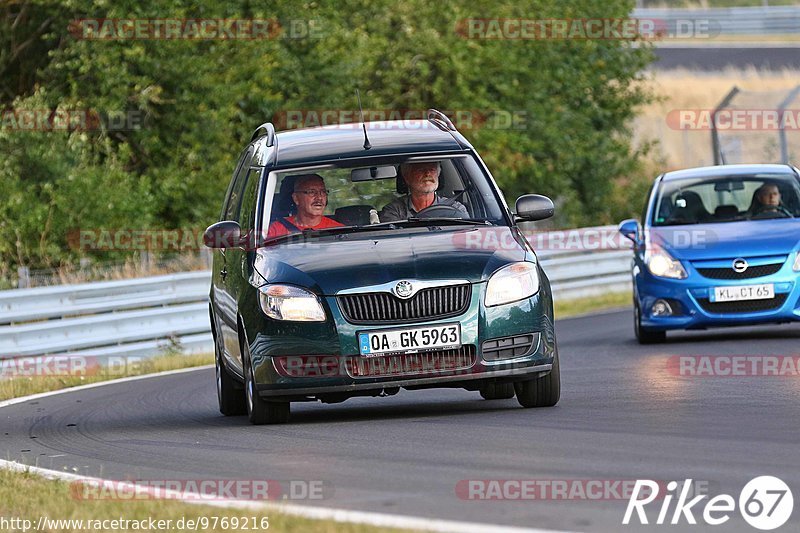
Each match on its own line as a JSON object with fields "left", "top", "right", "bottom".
{"left": 212, "top": 144, "right": 253, "bottom": 373}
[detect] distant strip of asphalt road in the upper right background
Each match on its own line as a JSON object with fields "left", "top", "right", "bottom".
{"left": 653, "top": 45, "right": 800, "bottom": 71}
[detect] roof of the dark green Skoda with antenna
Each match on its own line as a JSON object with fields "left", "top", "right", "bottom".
{"left": 257, "top": 120, "right": 471, "bottom": 168}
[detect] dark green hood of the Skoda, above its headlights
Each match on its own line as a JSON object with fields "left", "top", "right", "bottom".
{"left": 254, "top": 222, "right": 532, "bottom": 295}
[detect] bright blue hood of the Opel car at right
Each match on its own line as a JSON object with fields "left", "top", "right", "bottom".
{"left": 648, "top": 219, "right": 800, "bottom": 261}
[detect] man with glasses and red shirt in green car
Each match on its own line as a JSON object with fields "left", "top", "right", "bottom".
{"left": 267, "top": 174, "right": 344, "bottom": 239}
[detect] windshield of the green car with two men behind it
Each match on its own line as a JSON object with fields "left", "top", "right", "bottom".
{"left": 263, "top": 156, "right": 505, "bottom": 241}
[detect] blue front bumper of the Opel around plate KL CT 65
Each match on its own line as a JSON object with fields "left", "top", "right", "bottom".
{"left": 634, "top": 261, "right": 800, "bottom": 330}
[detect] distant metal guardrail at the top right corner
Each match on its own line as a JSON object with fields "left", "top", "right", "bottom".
{"left": 631, "top": 6, "right": 800, "bottom": 36}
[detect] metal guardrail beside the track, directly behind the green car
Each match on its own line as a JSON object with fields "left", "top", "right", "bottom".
{"left": 0, "top": 226, "right": 631, "bottom": 360}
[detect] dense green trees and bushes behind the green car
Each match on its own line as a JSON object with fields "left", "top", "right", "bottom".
{"left": 0, "top": 0, "right": 652, "bottom": 267}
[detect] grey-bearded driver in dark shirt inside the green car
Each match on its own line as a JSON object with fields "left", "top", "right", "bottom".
{"left": 380, "top": 161, "right": 469, "bottom": 222}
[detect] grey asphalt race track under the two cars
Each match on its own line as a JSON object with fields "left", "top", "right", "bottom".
{"left": 0, "top": 311, "right": 800, "bottom": 531}
